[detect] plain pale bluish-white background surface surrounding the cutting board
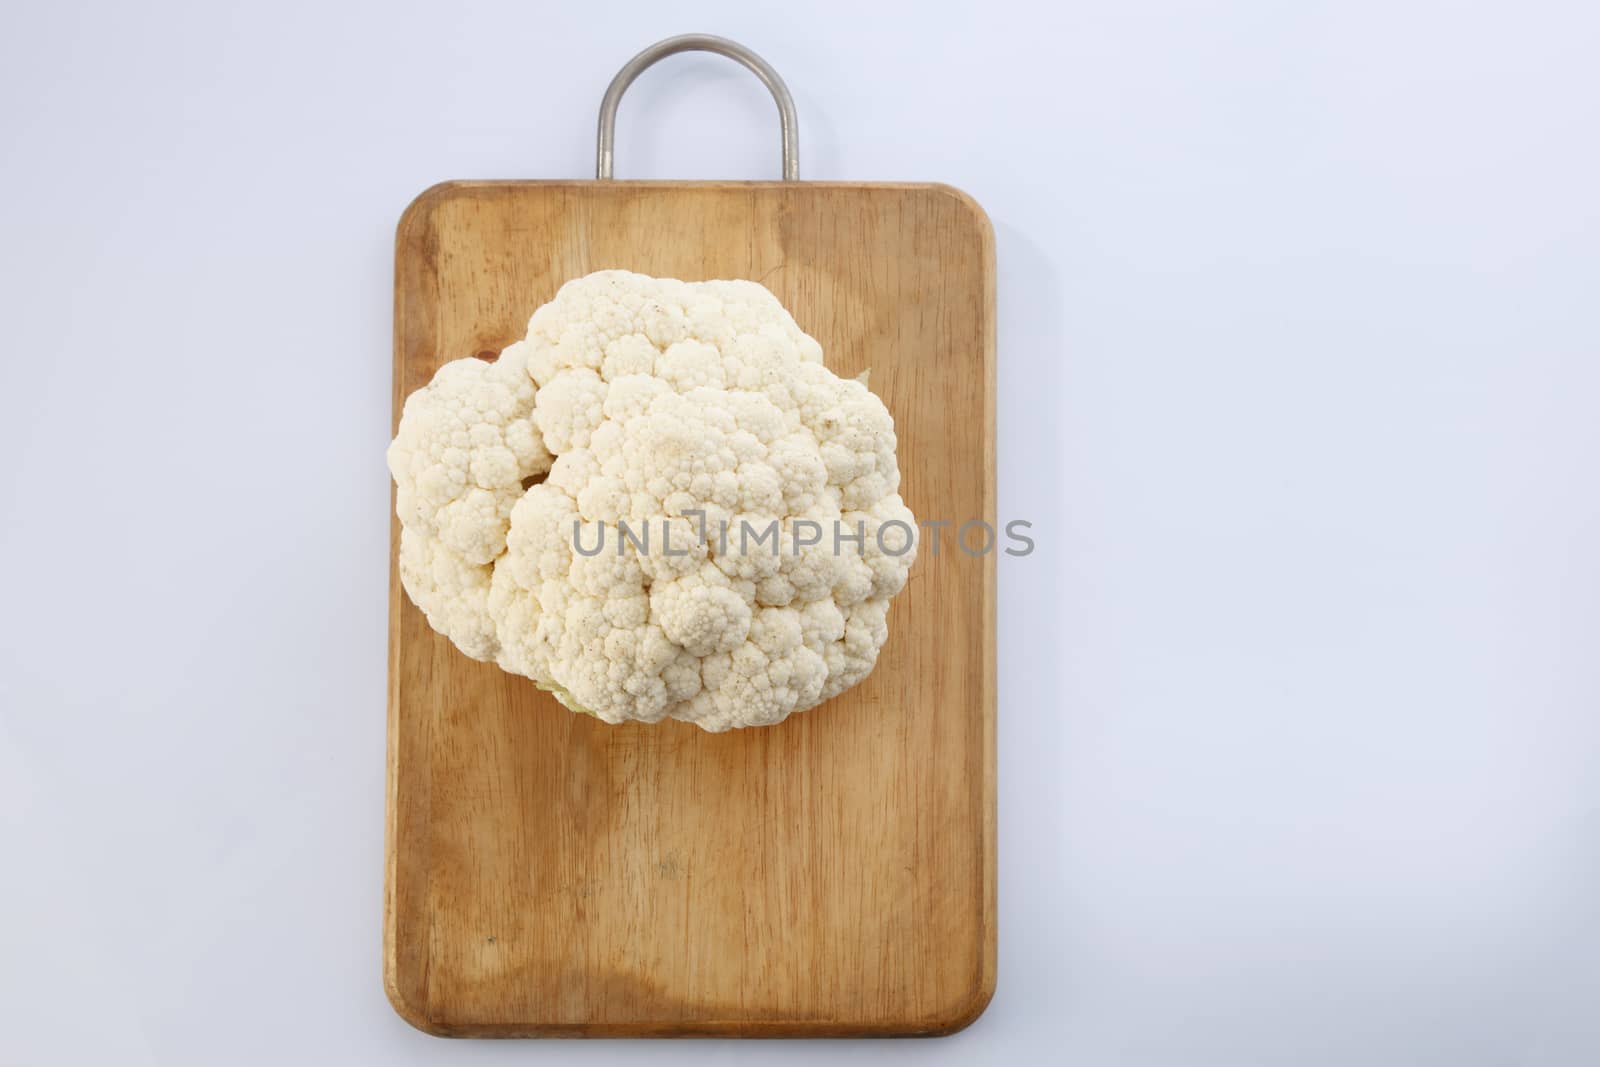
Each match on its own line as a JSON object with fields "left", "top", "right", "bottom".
{"left": 0, "top": 0, "right": 1600, "bottom": 1067}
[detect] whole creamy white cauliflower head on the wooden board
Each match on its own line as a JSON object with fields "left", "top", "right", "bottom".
{"left": 389, "top": 270, "right": 917, "bottom": 731}
